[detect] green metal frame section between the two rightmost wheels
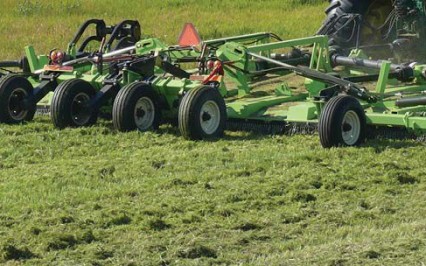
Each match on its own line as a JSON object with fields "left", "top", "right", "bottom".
{"left": 217, "top": 36, "right": 332, "bottom": 121}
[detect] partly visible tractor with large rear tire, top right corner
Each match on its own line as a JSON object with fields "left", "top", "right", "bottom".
{"left": 317, "top": 0, "right": 426, "bottom": 61}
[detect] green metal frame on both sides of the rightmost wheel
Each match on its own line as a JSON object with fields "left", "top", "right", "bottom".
{"left": 213, "top": 33, "right": 426, "bottom": 134}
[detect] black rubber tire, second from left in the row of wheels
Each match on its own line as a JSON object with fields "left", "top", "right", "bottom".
{"left": 50, "top": 79, "right": 98, "bottom": 129}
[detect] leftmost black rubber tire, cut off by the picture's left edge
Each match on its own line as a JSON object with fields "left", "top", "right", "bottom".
{"left": 0, "top": 74, "right": 37, "bottom": 124}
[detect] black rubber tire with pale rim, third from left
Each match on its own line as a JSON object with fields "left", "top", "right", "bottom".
{"left": 112, "top": 82, "right": 161, "bottom": 132}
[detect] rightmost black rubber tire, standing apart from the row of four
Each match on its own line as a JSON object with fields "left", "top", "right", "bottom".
{"left": 318, "top": 95, "right": 367, "bottom": 148}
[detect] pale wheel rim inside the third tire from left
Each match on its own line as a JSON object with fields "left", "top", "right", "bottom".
{"left": 134, "top": 97, "right": 155, "bottom": 131}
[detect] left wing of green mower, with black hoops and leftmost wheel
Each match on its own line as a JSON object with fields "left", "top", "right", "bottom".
{"left": 0, "top": 19, "right": 140, "bottom": 124}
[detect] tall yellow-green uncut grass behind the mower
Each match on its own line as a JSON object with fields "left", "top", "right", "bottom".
{"left": 0, "top": 0, "right": 325, "bottom": 59}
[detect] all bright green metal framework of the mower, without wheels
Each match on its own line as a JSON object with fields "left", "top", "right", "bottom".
{"left": 19, "top": 23, "right": 426, "bottom": 134}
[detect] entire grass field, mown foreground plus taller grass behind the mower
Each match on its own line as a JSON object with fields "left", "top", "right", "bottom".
{"left": 0, "top": 0, "right": 426, "bottom": 265}
